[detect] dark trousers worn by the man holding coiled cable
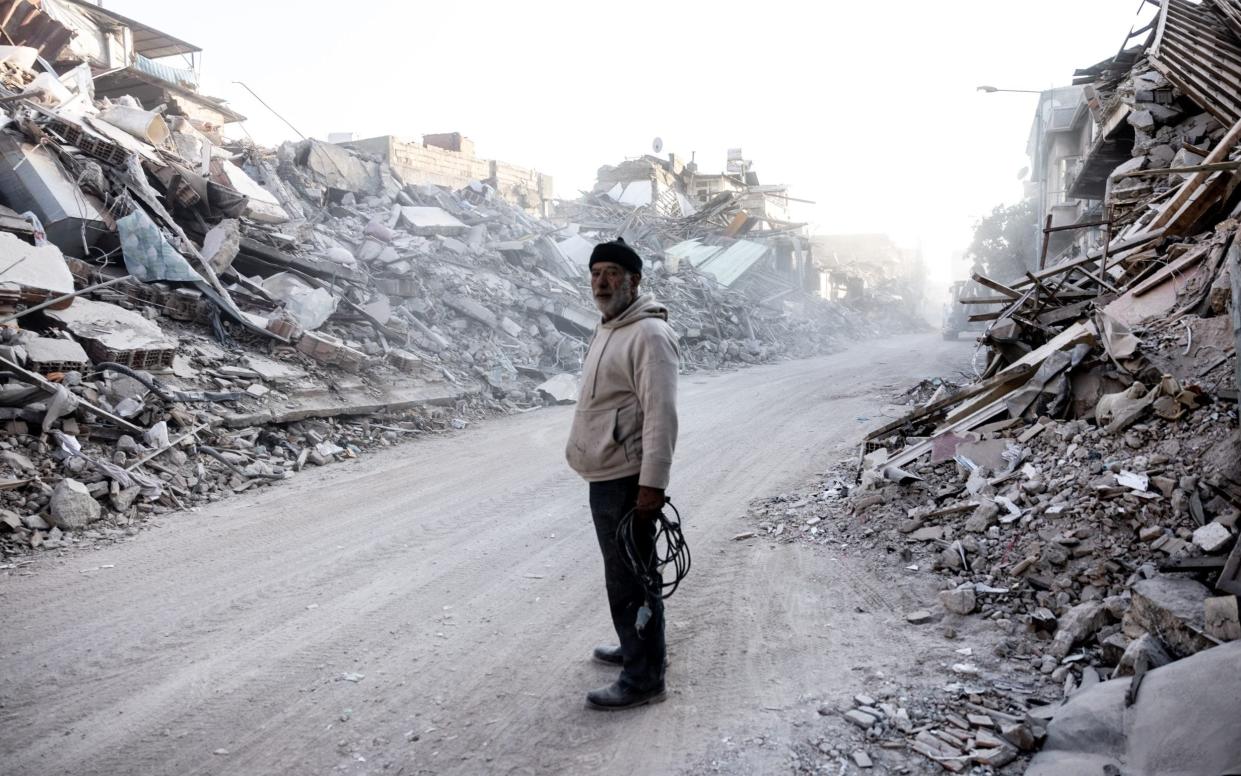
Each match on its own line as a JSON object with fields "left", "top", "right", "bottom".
{"left": 591, "top": 474, "right": 664, "bottom": 690}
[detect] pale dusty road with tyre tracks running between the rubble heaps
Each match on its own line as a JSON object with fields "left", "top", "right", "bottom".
{"left": 0, "top": 335, "right": 970, "bottom": 776}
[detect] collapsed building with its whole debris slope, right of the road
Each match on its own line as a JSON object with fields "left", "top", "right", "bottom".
{"left": 794, "top": 0, "right": 1241, "bottom": 774}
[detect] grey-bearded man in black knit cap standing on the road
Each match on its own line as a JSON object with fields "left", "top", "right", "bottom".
{"left": 566, "top": 240, "right": 680, "bottom": 710}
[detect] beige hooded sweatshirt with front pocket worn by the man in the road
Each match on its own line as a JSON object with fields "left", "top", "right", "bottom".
{"left": 565, "top": 294, "right": 680, "bottom": 489}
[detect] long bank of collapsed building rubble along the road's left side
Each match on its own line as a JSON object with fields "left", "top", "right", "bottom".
{"left": 0, "top": 0, "right": 923, "bottom": 554}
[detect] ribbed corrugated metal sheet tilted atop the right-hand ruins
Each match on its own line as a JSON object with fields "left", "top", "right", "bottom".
{"left": 1150, "top": 0, "right": 1241, "bottom": 127}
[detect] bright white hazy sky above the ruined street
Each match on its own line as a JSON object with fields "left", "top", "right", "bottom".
{"left": 104, "top": 0, "right": 1149, "bottom": 284}
